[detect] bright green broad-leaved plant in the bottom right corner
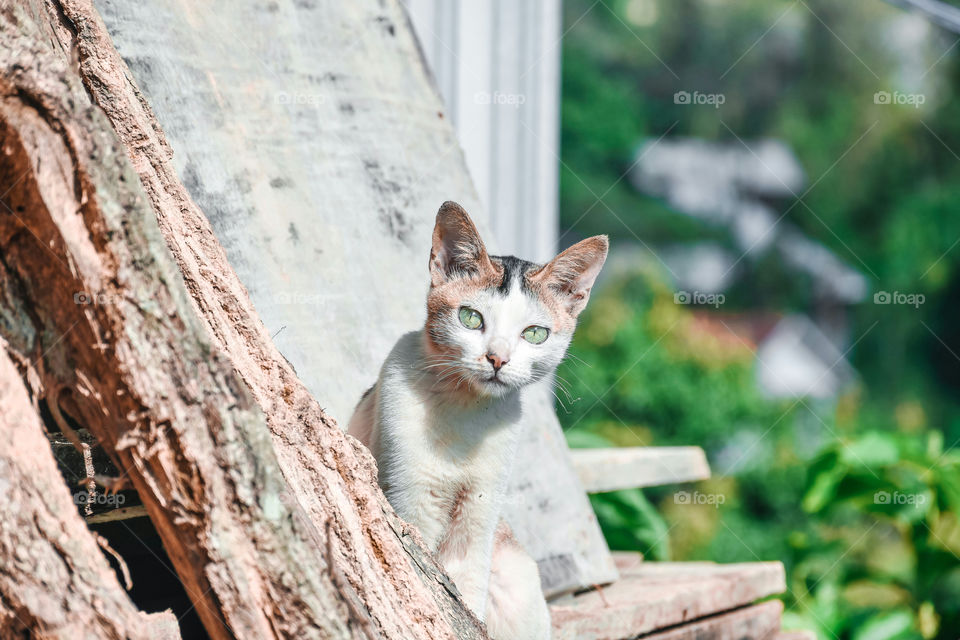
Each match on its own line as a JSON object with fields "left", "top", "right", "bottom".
{"left": 790, "top": 424, "right": 960, "bottom": 638}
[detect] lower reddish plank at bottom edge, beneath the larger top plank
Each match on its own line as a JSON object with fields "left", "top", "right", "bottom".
{"left": 643, "top": 600, "right": 783, "bottom": 640}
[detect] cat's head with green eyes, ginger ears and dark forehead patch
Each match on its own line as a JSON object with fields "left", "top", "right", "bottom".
{"left": 426, "top": 202, "right": 608, "bottom": 396}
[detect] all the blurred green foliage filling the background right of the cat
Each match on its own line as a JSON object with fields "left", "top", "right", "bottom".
{"left": 558, "top": 0, "right": 960, "bottom": 640}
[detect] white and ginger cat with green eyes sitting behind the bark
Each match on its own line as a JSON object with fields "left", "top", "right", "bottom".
{"left": 349, "top": 202, "right": 607, "bottom": 640}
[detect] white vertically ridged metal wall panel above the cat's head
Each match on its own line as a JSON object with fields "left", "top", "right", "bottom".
{"left": 404, "top": 0, "right": 561, "bottom": 261}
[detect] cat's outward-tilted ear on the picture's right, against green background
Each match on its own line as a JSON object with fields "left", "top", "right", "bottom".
{"left": 529, "top": 236, "right": 610, "bottom": 317}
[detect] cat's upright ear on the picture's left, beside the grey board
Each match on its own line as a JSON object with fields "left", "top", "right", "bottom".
{"left": 430, "top": 200, "right": 495, "bottom": 286}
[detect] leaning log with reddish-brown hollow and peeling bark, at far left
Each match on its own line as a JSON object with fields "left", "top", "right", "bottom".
{"left": 0, "top": 11, "right": 359, "bottom": 638}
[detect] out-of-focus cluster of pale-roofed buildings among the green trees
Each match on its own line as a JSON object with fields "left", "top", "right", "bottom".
{"left": 630, "top": 139, "right": 867, "bottom": 398}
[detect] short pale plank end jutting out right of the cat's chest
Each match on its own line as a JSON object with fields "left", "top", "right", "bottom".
{"left": 571, "top": 447, "right": 710, "bottom": 493}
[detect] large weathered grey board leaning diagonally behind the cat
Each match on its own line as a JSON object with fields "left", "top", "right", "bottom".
{"left": 96, "top": 0, "right": 616, "bottom": 593}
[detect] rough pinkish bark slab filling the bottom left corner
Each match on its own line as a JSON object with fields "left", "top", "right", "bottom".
{"left": 0, "top": 339, "right": 180, "bottom": 640}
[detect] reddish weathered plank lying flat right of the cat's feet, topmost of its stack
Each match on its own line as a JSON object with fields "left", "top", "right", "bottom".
{"left": 550, "top": 556, "right": 786, "bottom": 640}
